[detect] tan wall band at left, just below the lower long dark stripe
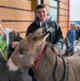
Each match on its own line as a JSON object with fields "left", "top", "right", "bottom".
{"left": 1, "top": 22, "right": 31, "bottom": 32}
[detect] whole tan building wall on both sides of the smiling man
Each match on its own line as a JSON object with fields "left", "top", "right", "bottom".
{"left": 0, "top": 0, "right": 68, "bottom": 38}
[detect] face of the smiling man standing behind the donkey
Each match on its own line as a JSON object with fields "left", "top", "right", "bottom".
{"left": 36, "top": 8, "right": 47, "bottom": 23}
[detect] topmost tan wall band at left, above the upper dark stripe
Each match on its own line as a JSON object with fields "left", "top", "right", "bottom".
{"left": 0, "top": 0, "right": 31, "bottom": 10}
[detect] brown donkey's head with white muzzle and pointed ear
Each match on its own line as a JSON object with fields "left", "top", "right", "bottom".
{"left": 7, "top": 32, "right": 49, "bottom": 70}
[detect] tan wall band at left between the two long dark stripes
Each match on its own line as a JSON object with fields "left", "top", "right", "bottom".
{"left": 0, "top": 8, "right": 35, "bottom": 20}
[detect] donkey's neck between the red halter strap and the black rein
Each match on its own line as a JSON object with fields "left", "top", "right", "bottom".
{"left": 33, "top": 45, "right": 56, "bottom": 81}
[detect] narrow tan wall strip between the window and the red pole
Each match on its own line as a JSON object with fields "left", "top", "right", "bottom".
{"left": 58, "top": 0, "right": 69, "bottom": 37}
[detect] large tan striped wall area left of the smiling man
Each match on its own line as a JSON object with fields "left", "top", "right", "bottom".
{"left": 0, "top": 0, "right": 34, "bottom": 37}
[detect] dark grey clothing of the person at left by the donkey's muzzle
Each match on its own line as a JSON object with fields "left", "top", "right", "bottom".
{"left": 0, "top": 29, "right": 27, "bottom": 81}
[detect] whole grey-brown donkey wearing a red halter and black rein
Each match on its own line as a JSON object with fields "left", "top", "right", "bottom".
{"left": 7, "top": 33, "right": 80, "bottom": 81}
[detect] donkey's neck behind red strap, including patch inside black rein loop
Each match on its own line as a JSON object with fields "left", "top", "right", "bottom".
{"left": 33, "top": 43, "right": 67, "bottom": 81}
